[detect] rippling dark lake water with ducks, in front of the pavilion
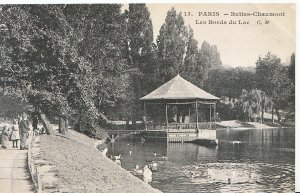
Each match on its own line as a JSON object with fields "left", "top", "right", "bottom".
{"left": 107, "top": 128, "right": 295, "bottom": 193}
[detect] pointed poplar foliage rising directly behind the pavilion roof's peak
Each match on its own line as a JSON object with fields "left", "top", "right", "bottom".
{"left": 157, "top": 8, "right": 222, "bottom": 87}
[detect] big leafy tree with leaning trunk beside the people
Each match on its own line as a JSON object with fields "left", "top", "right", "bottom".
{"left": 0, "top": 5, "right": 118, "bottom": 134}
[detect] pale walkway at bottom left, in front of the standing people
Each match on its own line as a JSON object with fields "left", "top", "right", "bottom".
{"left": 0, "top": 148, "right": 34, "bottom": 193}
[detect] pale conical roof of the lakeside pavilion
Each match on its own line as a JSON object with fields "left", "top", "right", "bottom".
{"left": 140, "top": 74, "right": 220, "bottom": 100}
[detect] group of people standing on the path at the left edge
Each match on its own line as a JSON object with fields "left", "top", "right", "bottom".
{"left": 1, "top": 113, "right": 30, "bottom": 150}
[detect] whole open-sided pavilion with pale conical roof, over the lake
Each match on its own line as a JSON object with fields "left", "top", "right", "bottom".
{"left": 140, "top": 74, "right": 220, "bottom": 131}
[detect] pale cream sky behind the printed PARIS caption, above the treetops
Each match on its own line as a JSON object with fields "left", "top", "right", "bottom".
{"left": 125, "top": 4, "right": 296, "bottom": 67}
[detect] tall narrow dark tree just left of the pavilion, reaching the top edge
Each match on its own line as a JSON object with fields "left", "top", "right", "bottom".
{"left": 126, "top": 4, "right": 158, "bottom": 124}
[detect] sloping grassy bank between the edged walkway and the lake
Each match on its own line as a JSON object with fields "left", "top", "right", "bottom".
{"left": 40, "top": 133, "right": 160, "bottom": 193}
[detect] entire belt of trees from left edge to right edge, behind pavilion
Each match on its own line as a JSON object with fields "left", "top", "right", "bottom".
{"left": 0, "top": 4, "right": 295, "bottom": 136}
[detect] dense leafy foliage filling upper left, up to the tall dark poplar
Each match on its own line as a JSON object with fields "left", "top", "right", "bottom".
{"left": 0, "top": 5, "right": 135, "bottom": 134}
